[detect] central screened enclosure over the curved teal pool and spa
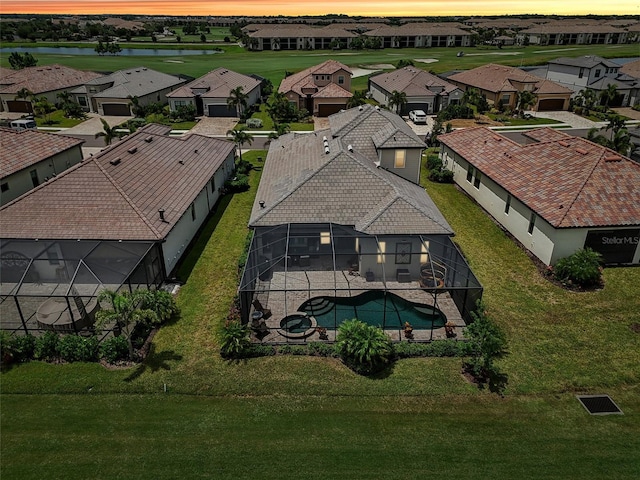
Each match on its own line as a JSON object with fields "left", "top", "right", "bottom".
{"left": 239, "top": 224, "right": 482, "bottom": 343}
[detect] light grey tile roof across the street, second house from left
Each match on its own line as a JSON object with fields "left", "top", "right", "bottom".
{"left": 73, "top": 67, "right": 185, "bottom": 98}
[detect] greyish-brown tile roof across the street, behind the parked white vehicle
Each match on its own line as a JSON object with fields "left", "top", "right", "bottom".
{"left": 370, "top": 67, "right": 459, "bottom": 97}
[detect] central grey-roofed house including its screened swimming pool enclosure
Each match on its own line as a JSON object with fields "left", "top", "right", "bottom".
{"left": 240, "top": 105, "right": 482, "bottom": 342}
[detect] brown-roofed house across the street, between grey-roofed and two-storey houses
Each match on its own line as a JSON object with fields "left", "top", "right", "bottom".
{"left": 167, "top": 67, "right": 261, "bottom": 117}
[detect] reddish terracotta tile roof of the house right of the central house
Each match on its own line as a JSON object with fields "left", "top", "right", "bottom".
{"left": 438, "top": 127, "right": 640, "bottom": 228}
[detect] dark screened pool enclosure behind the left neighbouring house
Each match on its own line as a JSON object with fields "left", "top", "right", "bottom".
{"left": 0, "top": 240, "right": 163, "bottom": 335}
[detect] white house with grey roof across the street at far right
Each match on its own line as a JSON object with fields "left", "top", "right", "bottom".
{"left": 546, "top": 55, "right": 640, "bottom": 107}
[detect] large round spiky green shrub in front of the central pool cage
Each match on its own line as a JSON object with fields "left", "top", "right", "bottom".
{"left": 336, "top": 318, "right": 393, "bottom": 375}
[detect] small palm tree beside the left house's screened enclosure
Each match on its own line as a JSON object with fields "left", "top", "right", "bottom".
{"left": 95, "top": 290, "right": 158, "bottom": 360}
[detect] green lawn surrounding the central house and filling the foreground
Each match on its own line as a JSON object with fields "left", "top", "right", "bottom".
{"left": 0, "top": 121, "right": 640, "bottom": 479}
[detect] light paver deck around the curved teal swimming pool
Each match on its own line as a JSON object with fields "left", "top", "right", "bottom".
{"left": 252, "top": 270, "right": 466, "bottom": 344}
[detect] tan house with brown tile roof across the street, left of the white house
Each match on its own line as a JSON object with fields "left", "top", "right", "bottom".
{"left": 447, "top": 63, "right": 573, "bottom": 112}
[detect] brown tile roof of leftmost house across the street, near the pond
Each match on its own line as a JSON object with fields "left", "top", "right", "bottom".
{"left": 0, "top": 65, "right": 102, "bottom": 94}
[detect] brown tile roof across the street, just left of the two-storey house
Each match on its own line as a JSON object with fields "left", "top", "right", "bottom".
{"left": 167, "top": 67, "right": 260, "bottom": 99}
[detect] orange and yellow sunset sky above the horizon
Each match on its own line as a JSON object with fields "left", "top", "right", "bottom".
{"left": 0, "top": 0, "right": 640, "bottom": 17}
